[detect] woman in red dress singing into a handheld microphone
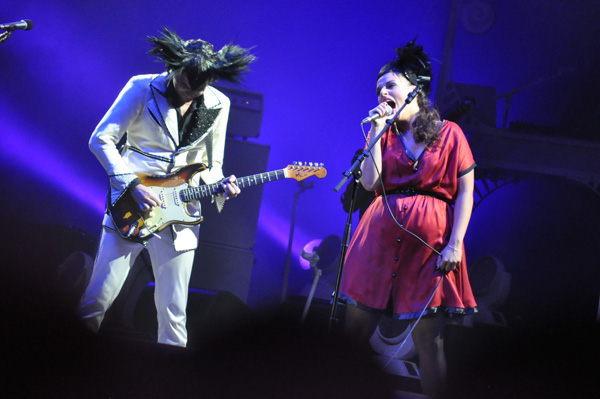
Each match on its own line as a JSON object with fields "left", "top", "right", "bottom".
{"left": 340, "top": 40, "right": 476, "bottom": 398}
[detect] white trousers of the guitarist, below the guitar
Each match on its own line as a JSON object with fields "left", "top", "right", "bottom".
{"left": 79, "top": 228, "right": 194, "bottom": 346}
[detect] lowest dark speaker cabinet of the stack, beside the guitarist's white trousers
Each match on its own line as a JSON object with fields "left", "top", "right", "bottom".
{"left": 190, "top": 242, "right": 255, "bottom": 302}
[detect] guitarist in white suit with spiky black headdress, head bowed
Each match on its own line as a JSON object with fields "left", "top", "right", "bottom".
{"left": 79, "top": 29, "right": 255, "bottom": 346}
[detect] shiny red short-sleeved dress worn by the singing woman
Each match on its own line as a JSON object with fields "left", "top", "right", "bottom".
{"left": 340, "top": 122, "right": 477, "bottom": 319}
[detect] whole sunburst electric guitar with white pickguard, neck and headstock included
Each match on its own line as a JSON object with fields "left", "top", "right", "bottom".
{"left": 108, "top": 162, "right": 327, "bottom": 243}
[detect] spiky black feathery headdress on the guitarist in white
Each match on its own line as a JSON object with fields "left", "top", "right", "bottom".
{"left": 148, "top": 27, "right": 256, "bottom": 88}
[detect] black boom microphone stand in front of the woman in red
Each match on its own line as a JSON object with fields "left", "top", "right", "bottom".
{"left": 329, "top": 84, "right": 422, "bottom": 330}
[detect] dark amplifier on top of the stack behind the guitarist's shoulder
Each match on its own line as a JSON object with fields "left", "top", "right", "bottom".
{"left": 214, "top": 84, "right": 263, "bottom": 138}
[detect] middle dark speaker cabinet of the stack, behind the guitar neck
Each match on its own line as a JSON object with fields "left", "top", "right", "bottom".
{"left": 200, "top": 138, "right": 270, "bottom": 249}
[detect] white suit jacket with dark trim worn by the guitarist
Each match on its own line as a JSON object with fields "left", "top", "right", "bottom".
{"left": 89, "top": 73, "right": 230, "bottom": 250}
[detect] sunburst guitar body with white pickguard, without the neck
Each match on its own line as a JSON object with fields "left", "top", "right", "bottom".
{"left": 109, "top": 164, "right": 206, "bottom": 243}
